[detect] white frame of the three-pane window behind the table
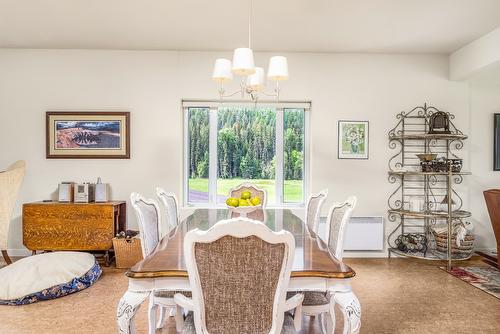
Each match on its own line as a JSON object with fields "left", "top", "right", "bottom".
{"left": 181, "top": 99, "right": 312, "bottom": 208}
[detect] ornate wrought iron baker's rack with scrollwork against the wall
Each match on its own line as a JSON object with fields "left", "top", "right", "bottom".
{"left": 387, "top": 104, "right": 471, "bottom": 267}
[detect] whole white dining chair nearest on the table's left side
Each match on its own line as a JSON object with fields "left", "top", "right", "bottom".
{"left": 130, "top": 193, "right": 190, "bottom": 334}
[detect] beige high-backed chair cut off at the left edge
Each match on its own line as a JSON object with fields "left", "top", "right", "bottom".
{"left": 0, "top": 160, "right": 26, "bottom": 265}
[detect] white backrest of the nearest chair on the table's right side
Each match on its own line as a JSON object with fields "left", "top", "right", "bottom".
{"left": 326, "top": 196, "right": 356, "bottom": 260}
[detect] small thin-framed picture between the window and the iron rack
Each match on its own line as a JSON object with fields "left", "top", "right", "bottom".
{"left": 338, "top": 121, "right": 369, "bottom": 159}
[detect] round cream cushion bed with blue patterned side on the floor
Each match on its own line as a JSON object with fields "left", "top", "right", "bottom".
{"left": 0, "top": 252, "right": 102, "bottom": 305}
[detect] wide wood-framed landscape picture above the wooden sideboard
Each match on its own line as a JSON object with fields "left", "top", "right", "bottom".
{"left": 46, "top": 111, "right": 130, "bottom": 159}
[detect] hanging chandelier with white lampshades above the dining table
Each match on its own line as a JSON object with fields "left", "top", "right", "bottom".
{"left": 212, "top": 0, "right": 288, "bottom": 101}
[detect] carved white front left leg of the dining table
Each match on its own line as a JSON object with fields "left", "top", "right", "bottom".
{"left": 116, "top": 291, "right": 151, "bottom": 334}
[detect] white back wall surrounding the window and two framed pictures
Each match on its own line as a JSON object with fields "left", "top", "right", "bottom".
{"left": 0, "top": 50, "right": 476, "bottom": 255}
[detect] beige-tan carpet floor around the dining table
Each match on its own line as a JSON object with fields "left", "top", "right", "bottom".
{"left": 0, "top": 259, "right": 500, "bottom": 334}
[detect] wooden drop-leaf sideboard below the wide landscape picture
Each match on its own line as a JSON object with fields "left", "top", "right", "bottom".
{"left": 23, "top": 201, "right": 127, "bottom": 265}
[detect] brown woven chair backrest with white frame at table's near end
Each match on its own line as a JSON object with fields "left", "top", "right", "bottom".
{"left": 184, "top": 218, "right": 295, "bottom": 334}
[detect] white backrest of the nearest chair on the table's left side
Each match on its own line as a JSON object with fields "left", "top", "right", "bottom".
{"left": 130, "top": 193, "right": 161, "bottom": 257}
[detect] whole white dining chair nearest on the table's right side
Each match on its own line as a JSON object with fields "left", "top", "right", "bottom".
{"left": 289, "top": 196, "right": 356, "bottom": 334}
